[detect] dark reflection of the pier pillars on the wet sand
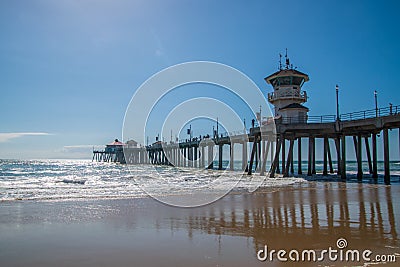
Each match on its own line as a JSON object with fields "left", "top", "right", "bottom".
{"left": 161, "top": 183, "right": 400, "bottom": 262}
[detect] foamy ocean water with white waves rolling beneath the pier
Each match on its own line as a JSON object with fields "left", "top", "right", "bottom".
{"left": 0, "top": 160, "right": 400, "bottom": 201}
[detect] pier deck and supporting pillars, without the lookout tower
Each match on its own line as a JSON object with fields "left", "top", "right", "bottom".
{"left": 93, "top": 106, "right": 400, "bottom": 184}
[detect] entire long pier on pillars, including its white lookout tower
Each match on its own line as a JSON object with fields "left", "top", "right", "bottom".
{"left": 93, "top": 55, "right": 400, "bottom": 184}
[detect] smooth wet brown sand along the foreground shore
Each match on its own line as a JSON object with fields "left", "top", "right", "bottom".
{"left": 0, "top": 182, "right": 400, "bottom": 266}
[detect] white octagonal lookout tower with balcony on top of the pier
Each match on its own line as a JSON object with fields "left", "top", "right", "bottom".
{"left": 264, "top": 51, "right": 309, "bottom": 123}
